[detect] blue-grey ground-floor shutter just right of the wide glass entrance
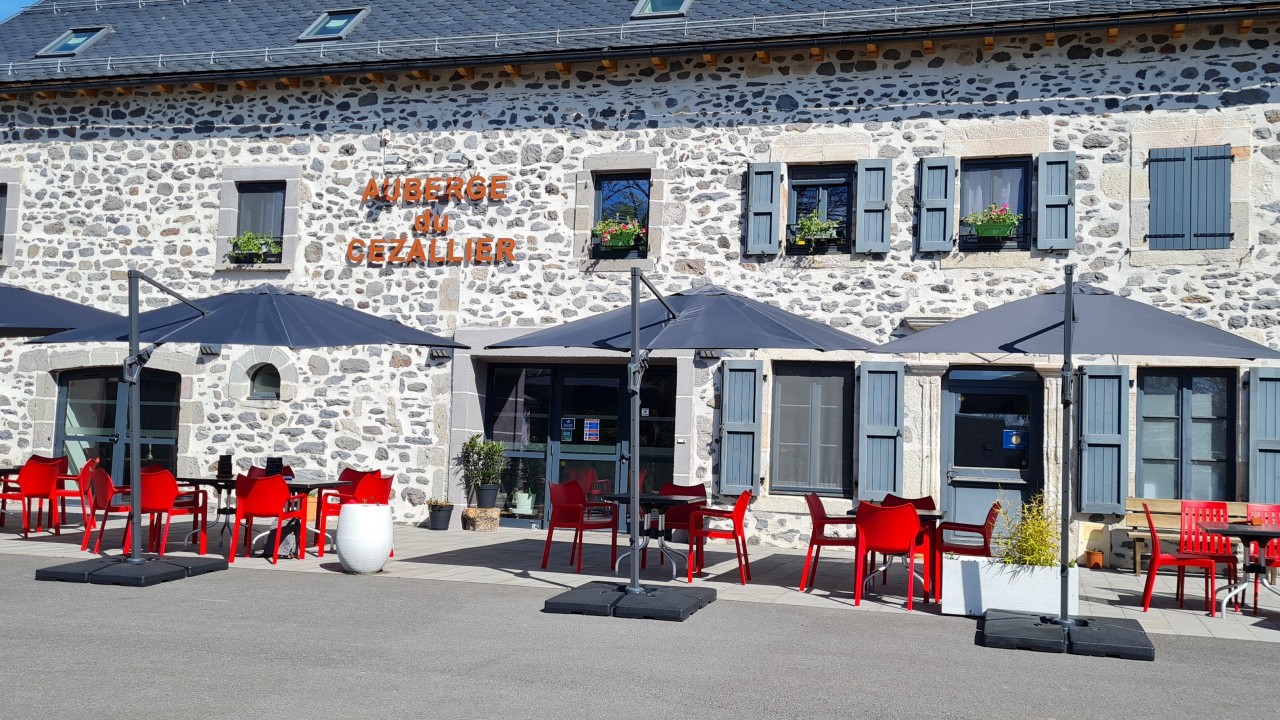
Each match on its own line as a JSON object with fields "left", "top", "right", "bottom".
{"left": 719, "top": 360, "right": 764, "bottom": 495}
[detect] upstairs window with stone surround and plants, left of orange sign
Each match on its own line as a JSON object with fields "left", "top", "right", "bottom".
{"left": 215, "top": 167, "right": 302, "bottom": 272}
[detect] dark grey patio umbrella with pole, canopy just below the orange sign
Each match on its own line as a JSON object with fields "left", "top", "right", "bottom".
{"left": 33, "top": 270, "right": 467, "bottom": 584}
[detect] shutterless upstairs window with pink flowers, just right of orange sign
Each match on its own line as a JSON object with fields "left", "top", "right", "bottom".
{"left": 591, "top": 170, "right": 653, "bottom": 259}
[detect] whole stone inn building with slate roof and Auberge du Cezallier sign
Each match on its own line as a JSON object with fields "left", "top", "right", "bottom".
{"left": 0, "top": 0, "right": 1280, "bottom": 555}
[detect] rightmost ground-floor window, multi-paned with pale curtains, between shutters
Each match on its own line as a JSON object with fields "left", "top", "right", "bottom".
{"left": 1137, "top": 369, "right": 1236, "bottom": 501}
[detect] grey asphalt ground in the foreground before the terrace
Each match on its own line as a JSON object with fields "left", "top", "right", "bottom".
{"left": 0, "top": 556, "right": 1280, "bottom": 720}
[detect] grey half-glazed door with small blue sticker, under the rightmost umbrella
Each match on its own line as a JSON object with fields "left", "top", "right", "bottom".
{"left": 942, "top": 369, "right": 1043, "bottom": 524}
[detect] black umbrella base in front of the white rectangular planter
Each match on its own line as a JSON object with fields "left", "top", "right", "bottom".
{"left": 978, "top": 610, "right": 1156, "bottom": 660}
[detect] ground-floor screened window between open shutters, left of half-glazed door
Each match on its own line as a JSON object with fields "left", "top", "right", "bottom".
{"left": 769, "top": 363, "right": 854, "bottom": 497}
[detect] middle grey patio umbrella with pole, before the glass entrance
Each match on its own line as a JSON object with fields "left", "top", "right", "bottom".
{"left": 489, "top": 274, "right": 873, "bottom": 594}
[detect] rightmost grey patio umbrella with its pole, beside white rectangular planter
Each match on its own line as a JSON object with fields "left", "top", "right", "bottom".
{"left": 872, "top": 265, "right": 1280, "bottom": 645}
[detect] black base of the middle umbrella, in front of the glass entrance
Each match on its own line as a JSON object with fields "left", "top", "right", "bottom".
{"left": 543, "top": 583, "right": 716, "bottom": 623}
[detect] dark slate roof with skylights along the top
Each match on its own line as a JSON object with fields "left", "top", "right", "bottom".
{"left": 0, "top": 0, "right": 1280, "bottom": 90}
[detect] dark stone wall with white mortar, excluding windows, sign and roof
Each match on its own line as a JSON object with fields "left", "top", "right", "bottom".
{"left": 0, "top": 24, "right": 1280, "bottom": 532}
